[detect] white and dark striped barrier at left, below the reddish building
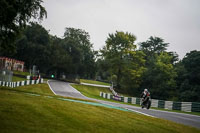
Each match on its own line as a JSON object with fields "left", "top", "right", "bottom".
{"left": 0, "top": 79, "right": 43, "bottom": 88}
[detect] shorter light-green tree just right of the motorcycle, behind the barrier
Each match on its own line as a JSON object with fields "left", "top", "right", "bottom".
{"left": 149, "top": 52, "right": 177, "bottom": 99}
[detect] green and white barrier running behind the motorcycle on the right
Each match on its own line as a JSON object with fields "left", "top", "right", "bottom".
{"left": 100, "top": 92, "right": 200, "bottom": 112}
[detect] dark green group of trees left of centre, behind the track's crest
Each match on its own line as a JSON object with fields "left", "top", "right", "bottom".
{"left": 6, "top": 23, "right": 95, "bottom": 78}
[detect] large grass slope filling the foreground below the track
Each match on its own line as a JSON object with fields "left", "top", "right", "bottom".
{"left": 0, "top": 85, "right": 200, "bottom": 133}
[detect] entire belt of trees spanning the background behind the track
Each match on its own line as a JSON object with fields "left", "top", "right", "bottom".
{"left": 0, "top": 23, "right": 200, "bottom": 102}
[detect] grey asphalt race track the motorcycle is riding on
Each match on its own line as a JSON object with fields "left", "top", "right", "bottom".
{"left": 48, "top": 81, "right": 200, "bottom": 129}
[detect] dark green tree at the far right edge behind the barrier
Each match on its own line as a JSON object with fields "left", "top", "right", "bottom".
{"left": 176, "top": 50, "right": 200, "bottom": 102}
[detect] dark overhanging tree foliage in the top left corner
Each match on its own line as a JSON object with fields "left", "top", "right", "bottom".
{"left": 0, "top": 0, "right": 47, "bottom": 56}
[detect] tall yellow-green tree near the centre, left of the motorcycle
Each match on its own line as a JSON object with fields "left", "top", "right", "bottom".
{"left": 101, "top": 31, "right": 144, "bottom": 92}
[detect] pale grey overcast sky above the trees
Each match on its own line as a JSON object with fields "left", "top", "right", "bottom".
{"left": 41, "top": 0, "right": 200, "bottom": 58}
